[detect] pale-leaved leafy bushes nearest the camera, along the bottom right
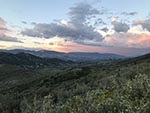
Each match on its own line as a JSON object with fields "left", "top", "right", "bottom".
{"left": 22, "top": 74, "right": 150, "bottom": 113}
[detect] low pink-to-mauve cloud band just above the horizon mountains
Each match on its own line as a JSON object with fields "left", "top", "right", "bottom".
{"left": 46, "top": 41, "right": 148, "bottom": 56}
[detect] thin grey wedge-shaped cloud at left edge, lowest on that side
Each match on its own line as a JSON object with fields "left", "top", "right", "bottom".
{"left": 0, "top": 34, "right": 23, "bottom": 43}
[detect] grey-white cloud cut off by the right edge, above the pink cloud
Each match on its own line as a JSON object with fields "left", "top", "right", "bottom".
{"left": 133, "top": 18, "right": 150, "bottom": 32}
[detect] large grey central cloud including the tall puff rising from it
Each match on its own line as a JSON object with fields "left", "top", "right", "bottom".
{"left": 21, "top": 3, "right": 103, "bottom": 44}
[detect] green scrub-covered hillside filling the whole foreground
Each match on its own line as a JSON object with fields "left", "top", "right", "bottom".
{"left": 0, "top": 54, "right": 150, "bottom": 113}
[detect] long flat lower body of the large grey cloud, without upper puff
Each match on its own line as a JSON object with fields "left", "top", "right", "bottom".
{"left": 22, "top": 23, "right": 102, "bottom": 40}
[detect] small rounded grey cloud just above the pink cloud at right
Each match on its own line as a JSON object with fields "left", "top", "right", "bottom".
{"left": 112, "top": 21, "right": 129, "bottom": 32}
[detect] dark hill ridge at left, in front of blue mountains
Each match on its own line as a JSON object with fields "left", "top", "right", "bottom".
{"left": 0, "top": 52, "right": 75, "bottom": 68}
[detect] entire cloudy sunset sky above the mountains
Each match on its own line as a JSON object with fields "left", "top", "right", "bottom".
{"left": 0, "top": 0, "right": 150, "bottom": 56}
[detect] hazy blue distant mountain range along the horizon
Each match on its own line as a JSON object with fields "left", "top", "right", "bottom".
{"left": 0, "top": 49, "right": 125, "bottom": 62}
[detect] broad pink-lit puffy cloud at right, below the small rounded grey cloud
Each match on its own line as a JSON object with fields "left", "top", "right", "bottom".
{"left": 103, "top": 32, "right": 150, "bottom": 48}
